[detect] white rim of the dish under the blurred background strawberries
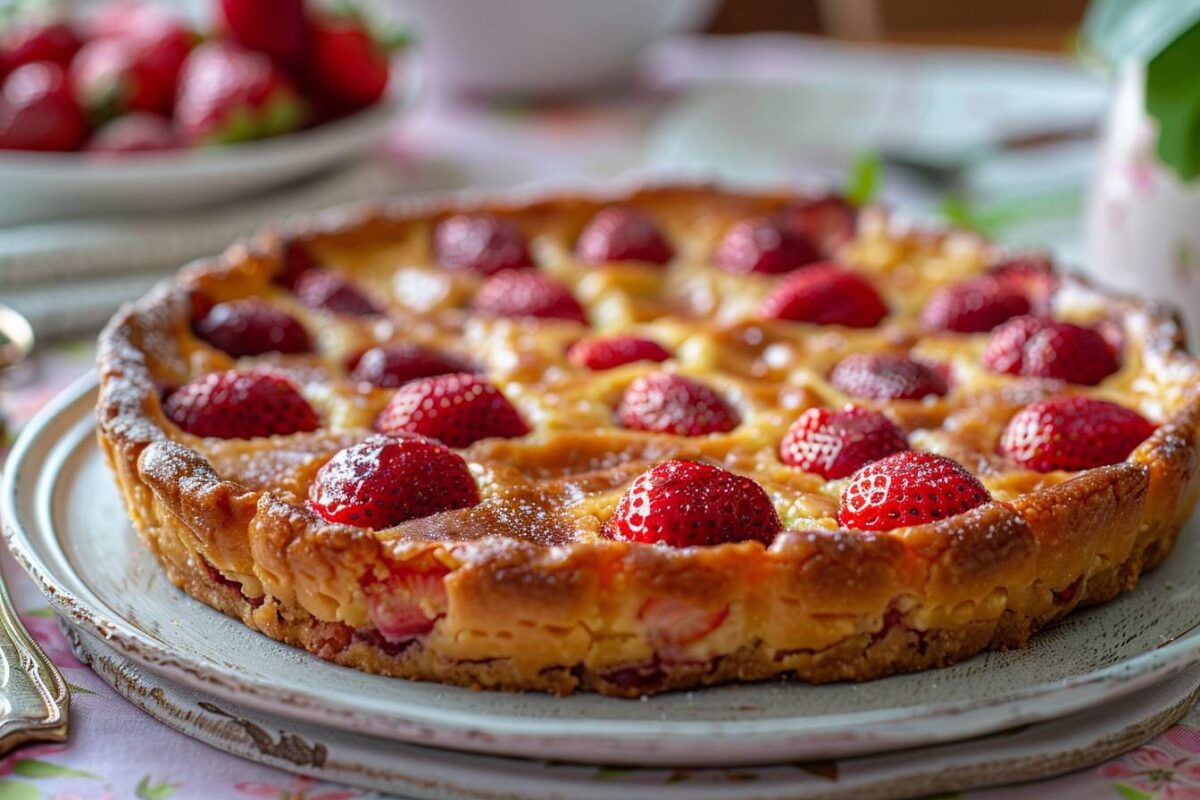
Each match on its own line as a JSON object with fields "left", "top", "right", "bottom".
{"left": 0, "top": 101, "right": 398, "bottom": 224}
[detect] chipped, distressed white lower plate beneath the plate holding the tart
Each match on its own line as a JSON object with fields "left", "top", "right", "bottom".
{"left": 72, "top": 633, "right": 1200, "bottom": 800}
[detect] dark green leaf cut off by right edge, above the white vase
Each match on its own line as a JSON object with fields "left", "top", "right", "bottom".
{"left": 1146, "top": 24, "right": 1200, "bottom": 181}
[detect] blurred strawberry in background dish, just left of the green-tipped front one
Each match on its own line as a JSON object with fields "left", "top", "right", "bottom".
{"left": 71, "top": 16, "right": 194, "bottom": 119}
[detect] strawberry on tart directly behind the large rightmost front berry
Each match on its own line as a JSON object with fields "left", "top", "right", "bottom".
{"left": 983, "top": 317, "right": 1121, "bottom": 386}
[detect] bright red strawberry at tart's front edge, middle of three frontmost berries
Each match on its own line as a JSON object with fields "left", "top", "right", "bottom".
{"left": 604, "top": 461, "right": 784, "bottom": 547}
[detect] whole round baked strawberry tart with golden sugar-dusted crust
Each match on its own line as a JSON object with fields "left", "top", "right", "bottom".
{"left": 97, "top": 185, "right": 1200, "bottom": 697}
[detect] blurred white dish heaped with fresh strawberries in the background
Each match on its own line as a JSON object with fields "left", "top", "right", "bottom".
{"left": 0, "top": 0, "right": 398, "bottom": 222}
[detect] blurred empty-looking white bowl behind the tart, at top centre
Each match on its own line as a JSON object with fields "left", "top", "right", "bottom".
{"left": 392, "top": 0, "right": 715, "bottom": 95}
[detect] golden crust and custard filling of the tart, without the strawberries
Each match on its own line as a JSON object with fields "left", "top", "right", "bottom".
{"left": 97, "top": 187, "right": 1200, "bottom": 697}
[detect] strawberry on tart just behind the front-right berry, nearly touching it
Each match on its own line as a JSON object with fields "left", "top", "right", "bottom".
{"left": 779, "top": 405, "right": 908, "bottom": 480}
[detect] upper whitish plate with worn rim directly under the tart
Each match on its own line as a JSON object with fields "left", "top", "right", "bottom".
{"left": 7, "top": 378, "right": 1200, "bottom": 766}
